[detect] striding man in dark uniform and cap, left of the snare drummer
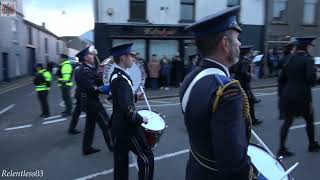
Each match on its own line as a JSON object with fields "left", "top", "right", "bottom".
{"left": 76, "top": 46, "right": 113, "bottom": 155}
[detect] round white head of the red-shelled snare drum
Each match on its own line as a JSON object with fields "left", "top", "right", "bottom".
{"left": 138, "top": 110, "right": 166, "bottom": 131}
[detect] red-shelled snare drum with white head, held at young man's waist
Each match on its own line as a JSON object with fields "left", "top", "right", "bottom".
{"left": 138, "top": 109, "right": 166, "bottom": 150}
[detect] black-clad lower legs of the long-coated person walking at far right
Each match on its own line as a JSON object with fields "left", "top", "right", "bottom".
{"left": 280, "top": 110, "right": 315, "bottom": 149}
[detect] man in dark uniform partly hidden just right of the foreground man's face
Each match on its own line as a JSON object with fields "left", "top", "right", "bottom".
{"left": 234, "top": 45, "right": 262, "bottom": 125}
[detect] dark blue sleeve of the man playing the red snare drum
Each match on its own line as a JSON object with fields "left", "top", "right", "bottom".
{"left": 112, "top": 78, "right": 143, "bottom": 126}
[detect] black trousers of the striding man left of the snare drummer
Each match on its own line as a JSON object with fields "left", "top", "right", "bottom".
{"left": 82, "top": 100, "right": 114, "bottom": 151}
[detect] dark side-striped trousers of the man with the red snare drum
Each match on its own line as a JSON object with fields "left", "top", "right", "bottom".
{"left": 114, "top": 129, "right": 154, "bottom": 180}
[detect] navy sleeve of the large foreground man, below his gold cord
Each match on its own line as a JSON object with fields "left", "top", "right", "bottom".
{"left": 210, "top": 86, "right": 250, "bottom": 180}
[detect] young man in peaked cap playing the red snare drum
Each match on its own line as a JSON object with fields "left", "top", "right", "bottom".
{"left": 109, "top": 44, "right": 154, "bottom": 180}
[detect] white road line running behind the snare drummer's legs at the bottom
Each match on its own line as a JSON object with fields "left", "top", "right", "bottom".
{"left": 74, "top": 149, "right": 190, "bottom": 180}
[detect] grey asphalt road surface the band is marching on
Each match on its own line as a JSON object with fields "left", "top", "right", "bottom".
{"left": 0, "top": 82, "right": 320, "bottom": 180}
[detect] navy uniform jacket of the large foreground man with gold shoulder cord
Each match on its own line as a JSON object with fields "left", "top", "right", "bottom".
{"left": 180, "top": 59, "right": 250, "bottom": 180}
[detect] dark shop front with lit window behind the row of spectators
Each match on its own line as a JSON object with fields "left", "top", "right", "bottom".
{"left": 94, "top": 23, "right": 196, "bottom": 64}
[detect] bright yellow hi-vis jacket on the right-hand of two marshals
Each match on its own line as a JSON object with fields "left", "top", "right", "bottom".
{"left": 58, "top": 60, "right": 73, "bottom": 86}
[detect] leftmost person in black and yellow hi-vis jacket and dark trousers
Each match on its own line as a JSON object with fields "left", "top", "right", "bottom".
{"left": 33, "top": 63, "right": 52, "bottom": 118}
